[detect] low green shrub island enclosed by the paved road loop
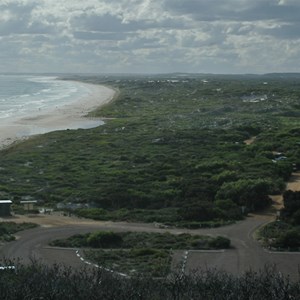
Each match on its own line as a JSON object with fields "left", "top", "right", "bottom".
{"left": 51, "top": 231, "right": 230, "bottom": 277}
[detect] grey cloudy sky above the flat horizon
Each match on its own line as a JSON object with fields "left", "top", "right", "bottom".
{"left": 0, "top": 0, "right": 300, "bottom": 73}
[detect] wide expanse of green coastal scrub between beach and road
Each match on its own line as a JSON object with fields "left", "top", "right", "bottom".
{"left": 0, "top": 74, "right": 300, "bottom": 225}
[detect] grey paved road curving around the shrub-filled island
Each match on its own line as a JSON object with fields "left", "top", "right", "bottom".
{"left": 0, "top": 216, "right": 300, "bottom": 280}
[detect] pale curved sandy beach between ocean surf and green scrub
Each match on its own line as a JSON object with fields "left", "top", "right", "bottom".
{"left": 0, "top": 82, "right": 116, "bottom": 149}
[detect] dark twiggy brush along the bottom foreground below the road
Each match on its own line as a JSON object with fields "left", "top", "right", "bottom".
{"left": 0, "top": 262, "right": 300, "bottom": 300}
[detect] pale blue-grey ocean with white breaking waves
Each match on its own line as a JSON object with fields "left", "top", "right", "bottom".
{"left": 0, "top": 75, "right": 89, "bottom": 121}
